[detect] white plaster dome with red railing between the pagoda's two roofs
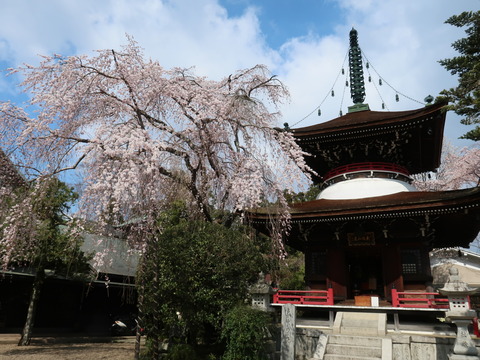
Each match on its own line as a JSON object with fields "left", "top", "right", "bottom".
{"left": 317, "top": 163, "right": 417, "bottom": 200}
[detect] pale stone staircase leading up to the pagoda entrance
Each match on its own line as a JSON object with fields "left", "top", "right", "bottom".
{"left": 311, "top": 312, "right": 392, "bottom": 360}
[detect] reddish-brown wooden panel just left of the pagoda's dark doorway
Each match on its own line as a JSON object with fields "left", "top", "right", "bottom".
{"left": 327, "top": 248, "right": 348, "bottom": 299}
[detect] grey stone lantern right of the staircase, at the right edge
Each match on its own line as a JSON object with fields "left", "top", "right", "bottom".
{"left": 438, "top": 267, "right": 478, "bottom": 360}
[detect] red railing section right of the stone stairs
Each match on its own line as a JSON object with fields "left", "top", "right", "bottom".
{"left": 392, "top": 289, "right": 449, "bottom": 309}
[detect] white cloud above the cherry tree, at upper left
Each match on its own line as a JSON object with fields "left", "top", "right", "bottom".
{"left": 0, "top": 0, "right": 275, "bottom": 77}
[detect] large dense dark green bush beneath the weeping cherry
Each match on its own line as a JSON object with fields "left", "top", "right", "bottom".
{"left": 139, "top": 203, "right": 269, "bottom": 358}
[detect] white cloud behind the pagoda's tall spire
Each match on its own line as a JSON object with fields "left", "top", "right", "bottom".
{"left": 270, "top": 0, "right": 480, "bottom": 143}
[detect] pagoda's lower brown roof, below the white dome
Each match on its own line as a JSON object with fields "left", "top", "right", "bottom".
{"left": 248, "top": 187, "right": 480, "bottom": 247}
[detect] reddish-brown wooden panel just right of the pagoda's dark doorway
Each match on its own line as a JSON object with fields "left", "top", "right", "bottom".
{"left": 382, "top": 245, "right": 403, "bottom": 299}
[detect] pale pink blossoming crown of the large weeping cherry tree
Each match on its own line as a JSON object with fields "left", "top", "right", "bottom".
{"left": 0, "top": 38, "right": 310, "bottom": 262}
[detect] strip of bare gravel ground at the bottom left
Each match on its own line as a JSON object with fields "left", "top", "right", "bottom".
{"left": 0, "top": 339, "right": 142, "bottom": 360}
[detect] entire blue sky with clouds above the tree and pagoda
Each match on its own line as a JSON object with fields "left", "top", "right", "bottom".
{"left": 0, "top": 0, "right": 480, "bottom": 145}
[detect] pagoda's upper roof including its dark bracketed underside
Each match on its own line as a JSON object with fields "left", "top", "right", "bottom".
{"left": 292, "top": 102, "right": 446, "bottom": 177}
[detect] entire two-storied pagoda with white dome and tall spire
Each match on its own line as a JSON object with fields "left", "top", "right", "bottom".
{"left": 252, "top": 29, "right": 480, "bottom": 300}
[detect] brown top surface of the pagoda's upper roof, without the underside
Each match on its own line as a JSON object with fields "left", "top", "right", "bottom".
{"left": 292, "top": 102, "right": 446, "bottom": 140}
